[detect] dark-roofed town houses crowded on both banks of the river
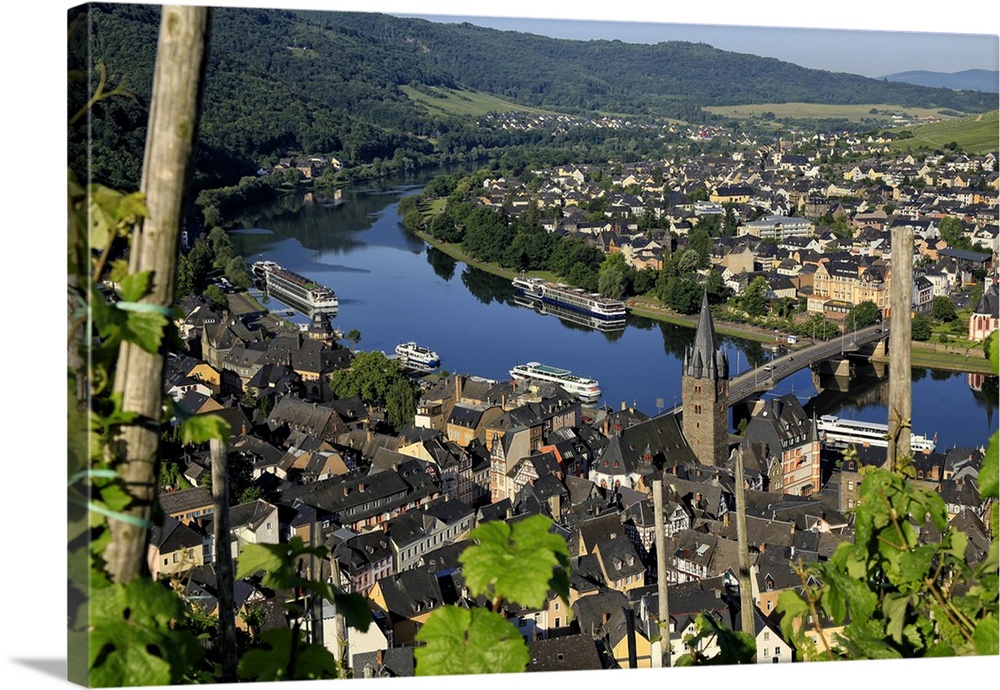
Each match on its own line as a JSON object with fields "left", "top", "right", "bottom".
{"left": 154, "top": 125, "right": 998, "bottom": 677}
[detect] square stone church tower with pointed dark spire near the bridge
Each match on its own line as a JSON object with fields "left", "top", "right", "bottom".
{"left": 681, "top": 293, "right": 729, "bottom": 466}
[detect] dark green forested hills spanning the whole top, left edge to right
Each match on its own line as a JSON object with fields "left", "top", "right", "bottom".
{"left": 69, "top": 4, "right": 997, "bottom": 188}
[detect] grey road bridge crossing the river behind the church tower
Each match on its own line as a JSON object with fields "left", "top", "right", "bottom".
{"left": 729, "top": 321, "right": 889, "bottom": 407}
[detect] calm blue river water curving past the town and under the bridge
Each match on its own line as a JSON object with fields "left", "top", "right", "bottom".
{"left": 231, "top": 176, "right": 997, "bottom": 450}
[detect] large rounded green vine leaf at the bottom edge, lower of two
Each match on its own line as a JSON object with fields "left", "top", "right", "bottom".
{"left": 413, "top": 606, "right": 531, "bottom": 676}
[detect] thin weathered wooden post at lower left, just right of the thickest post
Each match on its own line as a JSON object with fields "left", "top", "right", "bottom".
{"left": 208, "top": 438, "right": 237, "bottom": 683}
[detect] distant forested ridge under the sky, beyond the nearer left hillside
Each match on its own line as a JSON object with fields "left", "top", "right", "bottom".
{"left": 324, "top": 13, "right": 996, "bottom": 114}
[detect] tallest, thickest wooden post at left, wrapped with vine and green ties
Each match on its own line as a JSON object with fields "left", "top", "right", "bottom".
{"left": 104, "top": 5, "right": 208, "bottom": 582}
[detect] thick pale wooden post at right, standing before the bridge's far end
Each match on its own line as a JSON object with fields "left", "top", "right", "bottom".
{"left": 886, "top": 227, "right": 913, "bottom": 470}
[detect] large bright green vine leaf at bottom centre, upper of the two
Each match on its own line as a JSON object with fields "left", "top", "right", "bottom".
{"left": 459, "top": 515, "right": 569, "bottom": 608}
